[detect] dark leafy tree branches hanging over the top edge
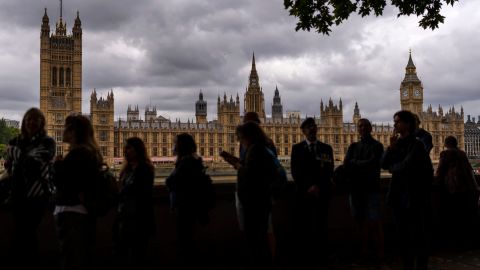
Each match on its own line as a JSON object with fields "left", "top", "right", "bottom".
{"left": 283, "top": 0, "right": 458, "bottom": 35}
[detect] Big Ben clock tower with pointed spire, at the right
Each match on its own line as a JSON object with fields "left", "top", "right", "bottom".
{"left": 400, "top": 51, "right": 423, "bottom": 116}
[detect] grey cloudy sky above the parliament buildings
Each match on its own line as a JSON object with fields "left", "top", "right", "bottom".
{"left": 0, "top": 0, "right": 480, "bottom": 122}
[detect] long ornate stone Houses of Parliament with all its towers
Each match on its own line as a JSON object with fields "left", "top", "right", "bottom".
{"left": 40, "top": 6, "right": 464, "bottom": 167}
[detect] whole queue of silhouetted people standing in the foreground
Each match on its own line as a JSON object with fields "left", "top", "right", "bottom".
{"left": 1, "top": 108, "right": 479, "bottom": 270}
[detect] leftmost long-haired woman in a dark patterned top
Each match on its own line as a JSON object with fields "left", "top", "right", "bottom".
{"left": 5, "top": 108, "right": 55, "bottom": 269}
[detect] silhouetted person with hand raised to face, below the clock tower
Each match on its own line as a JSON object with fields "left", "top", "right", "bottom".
{"left": 382, "top": 111, "right": 433, "bottom": 270}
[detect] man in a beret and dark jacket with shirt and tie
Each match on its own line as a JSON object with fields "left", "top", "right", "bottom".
{"left": 291, "top": 118, "right": 334, "bottom": 266}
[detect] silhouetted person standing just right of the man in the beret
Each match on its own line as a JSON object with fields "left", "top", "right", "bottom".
{"left": 343, "top": 118, "right": 384, "bottom": 264}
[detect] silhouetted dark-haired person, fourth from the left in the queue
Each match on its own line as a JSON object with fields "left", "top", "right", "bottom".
{"left": 166, "top": 133, "right": 208, "bottom": 267}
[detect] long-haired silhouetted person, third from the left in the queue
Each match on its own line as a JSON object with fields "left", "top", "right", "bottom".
{"left": 113, "top": 137, "right": 155, "bottom": 269}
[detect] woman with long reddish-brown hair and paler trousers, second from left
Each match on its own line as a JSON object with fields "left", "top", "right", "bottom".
{"left": 53, "top": 114, "right": 103, "bottom": 270}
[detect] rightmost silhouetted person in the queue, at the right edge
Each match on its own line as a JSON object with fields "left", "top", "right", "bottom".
{"left": 436, "top": 136, "right": 479, "bottom": 248}
